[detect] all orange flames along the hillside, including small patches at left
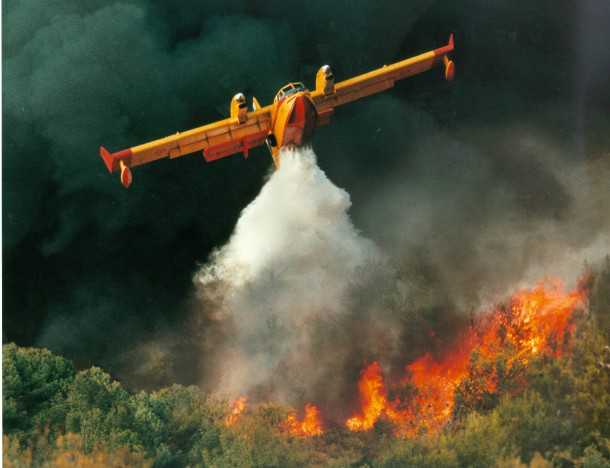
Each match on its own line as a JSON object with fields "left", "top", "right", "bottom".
{"left": 227, "top": 280, "right": 586, "bottom": 437}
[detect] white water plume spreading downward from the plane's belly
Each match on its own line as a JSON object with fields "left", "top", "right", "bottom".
{"left": 194, "top": 148, "right": 397, "bottom": 414}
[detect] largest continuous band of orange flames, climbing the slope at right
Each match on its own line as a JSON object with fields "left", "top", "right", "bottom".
{"left": 345, "top": 282, "right": 585, "bottom": 437}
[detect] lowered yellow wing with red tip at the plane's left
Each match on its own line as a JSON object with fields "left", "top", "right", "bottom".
{"left": 100, "top": 106, "right": 271, "bottom": 187}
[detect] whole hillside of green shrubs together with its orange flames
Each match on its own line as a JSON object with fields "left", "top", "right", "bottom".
{"left": 3, "top": 264, "right": 610, "bottom": 467}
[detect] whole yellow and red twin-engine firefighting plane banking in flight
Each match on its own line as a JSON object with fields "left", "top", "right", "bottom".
{"left": 100, "top": 34, "right": 455, "bottom": 187}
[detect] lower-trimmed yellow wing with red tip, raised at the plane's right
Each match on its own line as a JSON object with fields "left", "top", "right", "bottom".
{"left": 311, "top": 34, "right": 455, "bottom": 119}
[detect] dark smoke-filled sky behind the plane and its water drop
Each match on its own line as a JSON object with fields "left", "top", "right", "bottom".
{"left": 2, "top": 0, "right": 610, "bottom": 394}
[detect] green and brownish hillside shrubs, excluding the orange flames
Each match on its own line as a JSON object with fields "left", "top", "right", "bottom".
{"left": 3, "top": 267, "right": 610, "bottom": 467}
